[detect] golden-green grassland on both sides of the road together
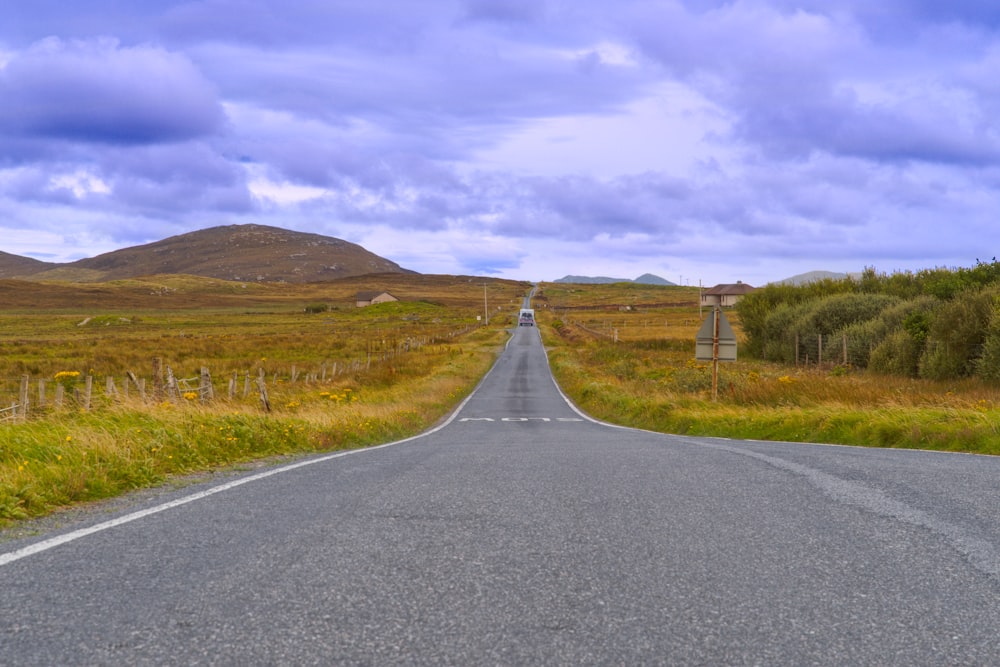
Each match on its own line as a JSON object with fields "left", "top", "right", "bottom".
{"left": 0, "top": 274, "right": 1000, "bottom": 525}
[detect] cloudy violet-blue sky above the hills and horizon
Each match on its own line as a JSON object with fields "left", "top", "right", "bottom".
{"left": 0, "top": 0, "right": 1000, "bottom": 286}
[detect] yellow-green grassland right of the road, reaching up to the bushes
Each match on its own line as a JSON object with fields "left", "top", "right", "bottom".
{"left": 540, "top": 285, "right": 1000, "bottom": 454}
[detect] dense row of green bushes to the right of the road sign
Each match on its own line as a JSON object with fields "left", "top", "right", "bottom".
{"left": 737, "top": 259, "right": 1000, "bottom": 383}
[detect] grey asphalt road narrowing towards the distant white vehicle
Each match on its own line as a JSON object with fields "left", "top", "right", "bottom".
{"left": 0, "top": 327, "right": 1000, "bottom": 665}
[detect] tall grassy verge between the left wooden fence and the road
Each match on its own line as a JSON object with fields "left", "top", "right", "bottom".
{"left": 0, "top": 329, "right": 505, "bottom": 526}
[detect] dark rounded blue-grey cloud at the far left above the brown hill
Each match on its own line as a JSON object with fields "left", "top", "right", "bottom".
{"left": 0, "top": 38, "right": 224, "bottom": 145}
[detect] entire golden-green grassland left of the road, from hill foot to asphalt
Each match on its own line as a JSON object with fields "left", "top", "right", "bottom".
{"left": 0, "top": 276, "right": 528, "bottom": 525}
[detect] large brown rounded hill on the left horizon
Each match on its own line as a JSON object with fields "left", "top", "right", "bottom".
{"left": 0, "top": 225, "right": 412, "bottom": 283}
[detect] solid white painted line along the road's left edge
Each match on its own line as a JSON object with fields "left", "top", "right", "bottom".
{"left": 0, "top": 350, "right": 500, "bottom": 567}
